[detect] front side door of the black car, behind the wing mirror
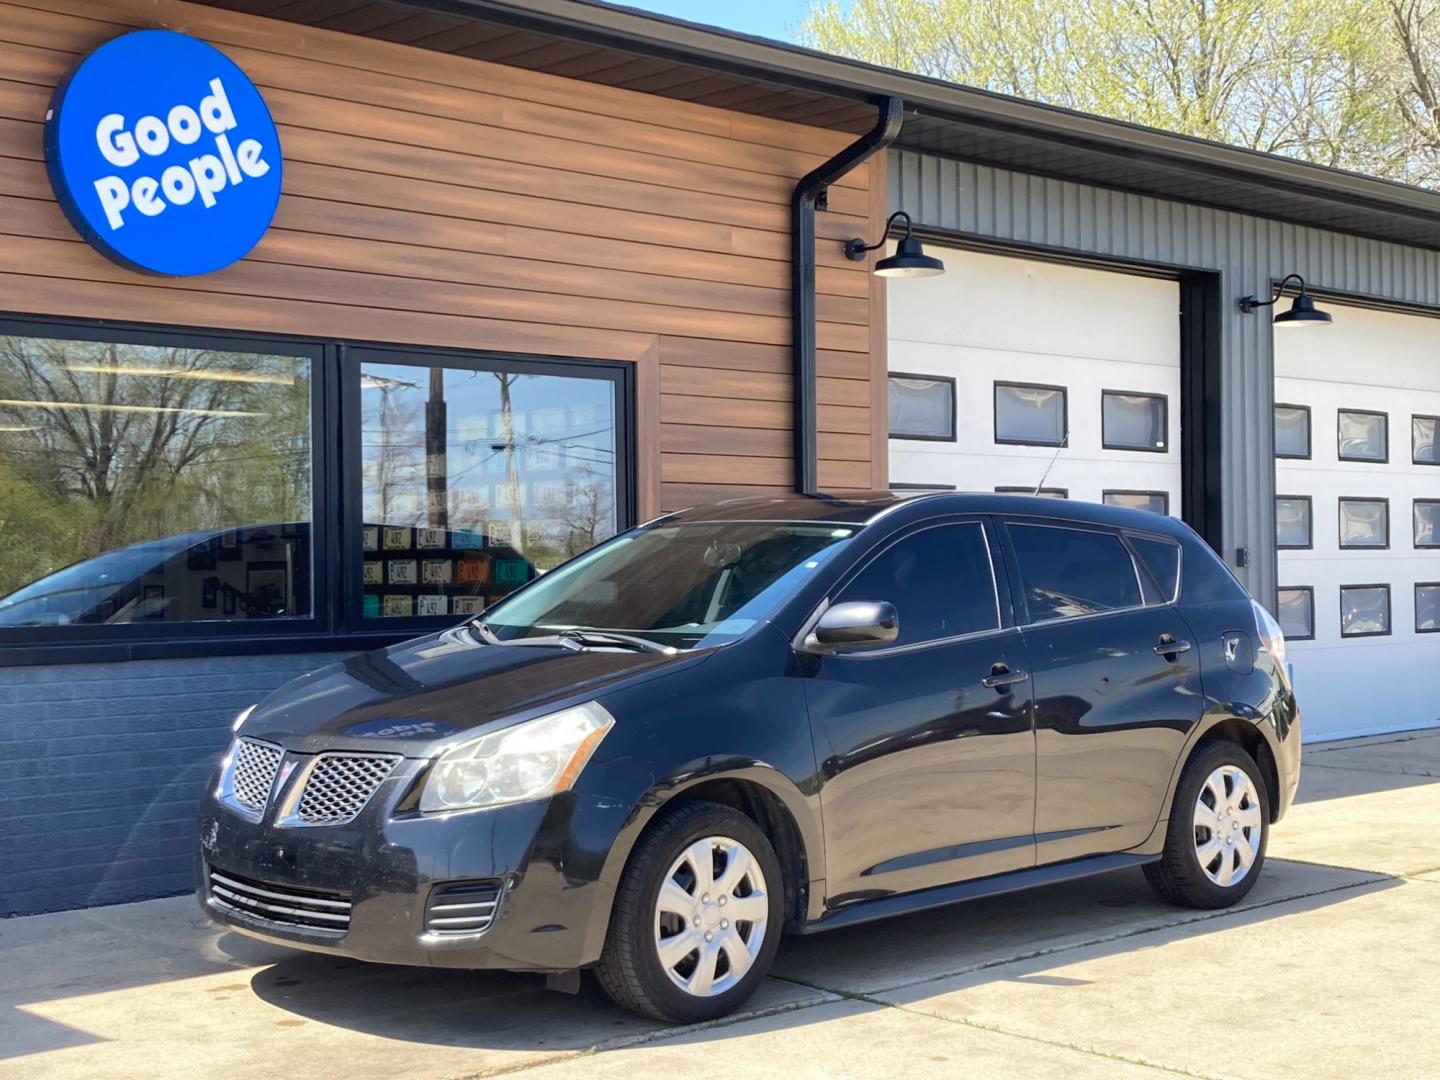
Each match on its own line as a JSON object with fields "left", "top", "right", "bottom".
{"left": 802, "top": 518, "right": 1035, "bottom": 906}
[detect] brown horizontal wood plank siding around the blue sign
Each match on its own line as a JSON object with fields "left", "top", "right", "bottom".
{"left": 0, "top": 0, "right": 886, "bottom": 514}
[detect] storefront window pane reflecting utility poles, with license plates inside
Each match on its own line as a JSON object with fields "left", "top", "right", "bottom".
{"left": 359, "top": 356, "right": 621, "bottom": 619}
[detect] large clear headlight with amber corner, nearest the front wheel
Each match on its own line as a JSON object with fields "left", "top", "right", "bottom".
{"left": 420, "top": 701, "right": 615, "bottom": 814}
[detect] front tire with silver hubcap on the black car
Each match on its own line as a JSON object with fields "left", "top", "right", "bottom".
{"left": 595, "top": 802, "right": 785, "bottom": 1024}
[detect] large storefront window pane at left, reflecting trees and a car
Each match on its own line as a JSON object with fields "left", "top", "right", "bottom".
{"left": 0, "top": 334, "right": 314, "bottom": 628}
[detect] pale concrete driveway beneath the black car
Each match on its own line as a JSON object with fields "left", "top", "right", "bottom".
{"left": 0, "top": 732, "right": 1440, "bottom": 1080}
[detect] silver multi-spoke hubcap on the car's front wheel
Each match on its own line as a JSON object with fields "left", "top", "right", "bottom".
{"left": 655, "top": 837, "right": 770, "bottom": 998}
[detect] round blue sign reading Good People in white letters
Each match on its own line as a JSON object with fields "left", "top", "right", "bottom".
{"left": 45, "top": 30, "right": 281, "bottom": 276}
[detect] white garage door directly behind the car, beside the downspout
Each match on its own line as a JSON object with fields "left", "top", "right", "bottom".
{"left": 888, "top": 248, "right": 1181, "bottom": 516}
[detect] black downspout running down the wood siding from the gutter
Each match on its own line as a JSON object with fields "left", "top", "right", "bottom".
{"left": 791, "top": 98, "right": 904, "bottom": 495}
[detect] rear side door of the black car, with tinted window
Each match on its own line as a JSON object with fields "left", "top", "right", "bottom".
{"left": 1004, "top": 520, "right": 1204, "bottom": 864}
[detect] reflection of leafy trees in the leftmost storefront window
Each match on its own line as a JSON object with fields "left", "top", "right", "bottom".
{"left": 0, "top": 336, "right": 311, "bottom": 596}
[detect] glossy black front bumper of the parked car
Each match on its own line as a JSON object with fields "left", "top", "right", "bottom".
{"left": 196, "top": 760, "right": 628, "bottom": 971}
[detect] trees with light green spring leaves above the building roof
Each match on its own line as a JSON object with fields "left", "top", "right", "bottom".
{"left": 801, "top": 0, "right": 1440, "bottom": 183}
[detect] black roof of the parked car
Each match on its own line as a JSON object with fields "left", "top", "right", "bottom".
{"left": 665, "top": 491, "right": 1185, "bottom": 536}
